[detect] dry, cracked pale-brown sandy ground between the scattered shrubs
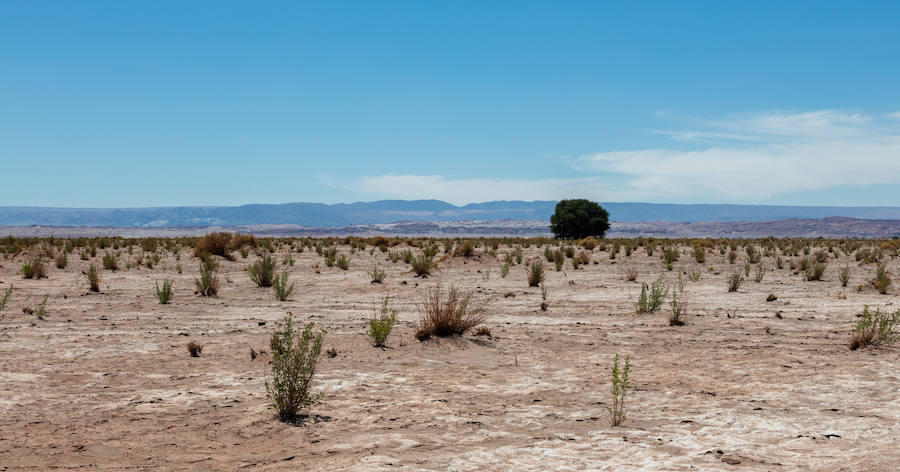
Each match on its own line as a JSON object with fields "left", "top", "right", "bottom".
{"left": 0, "top": 242, "right": 900, "bottom": 471}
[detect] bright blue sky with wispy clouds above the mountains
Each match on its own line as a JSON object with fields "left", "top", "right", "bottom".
{"left": 0, "top": 0, "right": 900, "bottom": 207}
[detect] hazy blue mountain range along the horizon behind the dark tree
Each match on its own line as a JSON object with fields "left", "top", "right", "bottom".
{"left": 0, "top": 200, "right": 900, "bottom": 228}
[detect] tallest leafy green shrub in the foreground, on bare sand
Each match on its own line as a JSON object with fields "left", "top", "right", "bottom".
{"left": 266, "top": 313, "right": 323, "bottom": 421}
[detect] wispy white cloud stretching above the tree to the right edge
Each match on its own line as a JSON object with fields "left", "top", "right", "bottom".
{"left": 350, "top": 110, "right": 900, "bottom": 203}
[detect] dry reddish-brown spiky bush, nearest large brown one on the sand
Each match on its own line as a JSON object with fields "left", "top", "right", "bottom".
{"left": 416, "top": 286, "right": 490, "bottom": 341}
